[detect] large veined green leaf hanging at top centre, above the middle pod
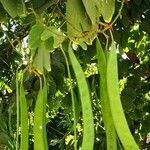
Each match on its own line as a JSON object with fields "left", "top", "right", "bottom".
{"left": 66, "top": 0, "right": 92, "bottom": 36}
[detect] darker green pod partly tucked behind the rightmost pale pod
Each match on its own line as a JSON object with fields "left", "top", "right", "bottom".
{"left": 96, "top": 38, "right": 117, "bottom": 150}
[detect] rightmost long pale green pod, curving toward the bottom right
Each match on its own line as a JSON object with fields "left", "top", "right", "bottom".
{"left": 107, "top": 43, "right": 139, "bottom": 150}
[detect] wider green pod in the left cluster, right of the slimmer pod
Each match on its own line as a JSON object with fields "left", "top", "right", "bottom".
{"left": 34, "top": 78, "right": 48, "bottom": 150}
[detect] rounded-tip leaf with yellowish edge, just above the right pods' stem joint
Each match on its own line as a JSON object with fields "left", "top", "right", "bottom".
{"left": 99, "top": 0, "right": 115, "bottom": 23}
